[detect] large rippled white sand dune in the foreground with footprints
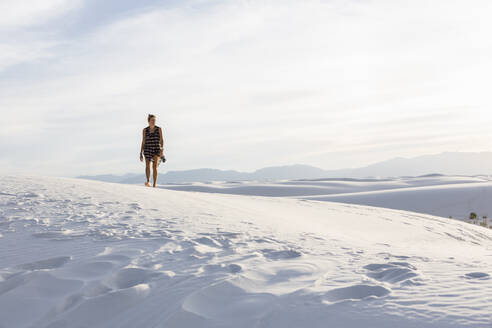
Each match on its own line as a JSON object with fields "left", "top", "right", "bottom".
{"left": 0, "top": 176, "right": 492, "bottom": 328}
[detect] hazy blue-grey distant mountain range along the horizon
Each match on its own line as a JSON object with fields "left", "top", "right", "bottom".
{"left": 78, "top": 152, "right": 492, "bottom": 184}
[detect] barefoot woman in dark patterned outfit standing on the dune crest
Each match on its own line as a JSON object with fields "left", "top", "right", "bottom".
{"left": 140, "top": 114, "right": 164, "bottom": 188}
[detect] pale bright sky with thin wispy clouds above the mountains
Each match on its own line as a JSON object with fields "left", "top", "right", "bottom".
{"left": 0, "top": 0, "right": 492, "bottom": 176}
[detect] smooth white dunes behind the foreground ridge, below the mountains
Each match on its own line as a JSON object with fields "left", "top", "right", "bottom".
{"left": 162, "top": 175, "right": 492, "bottom": 219}
